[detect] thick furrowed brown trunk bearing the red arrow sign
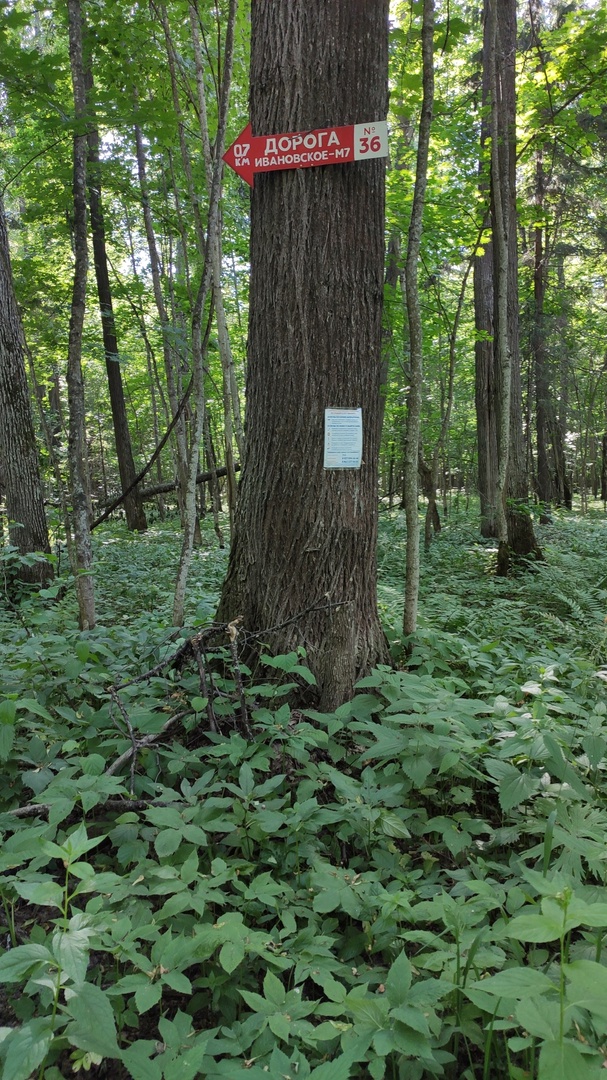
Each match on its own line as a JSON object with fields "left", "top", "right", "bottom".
{"left": 218, "top": 0, "right": 388, "bottom": 708}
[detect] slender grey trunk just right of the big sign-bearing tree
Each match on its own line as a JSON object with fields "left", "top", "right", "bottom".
{"left": 403, "top": 0, "right": 434, "bottom": 636}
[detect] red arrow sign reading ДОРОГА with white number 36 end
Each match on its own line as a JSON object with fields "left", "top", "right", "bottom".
{"left": 224, "top": 120, "right": 388, "bottom": 187}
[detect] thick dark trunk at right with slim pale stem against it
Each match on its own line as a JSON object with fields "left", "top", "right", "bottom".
{"left": 474, "top": 0, "right": 541, "bottom": 573}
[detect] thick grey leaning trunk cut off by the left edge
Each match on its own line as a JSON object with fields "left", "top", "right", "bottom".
{"left": 0, "top": 195, "right": 53, "bottom": 581}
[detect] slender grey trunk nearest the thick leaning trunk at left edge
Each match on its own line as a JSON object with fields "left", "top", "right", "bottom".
{"left": 67, "top": 0, "right": 95, "bottom": 630}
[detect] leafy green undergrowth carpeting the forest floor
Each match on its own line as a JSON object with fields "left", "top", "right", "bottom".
{"left": 0, "top": 514, "right": 607, "bottom": 1080}
